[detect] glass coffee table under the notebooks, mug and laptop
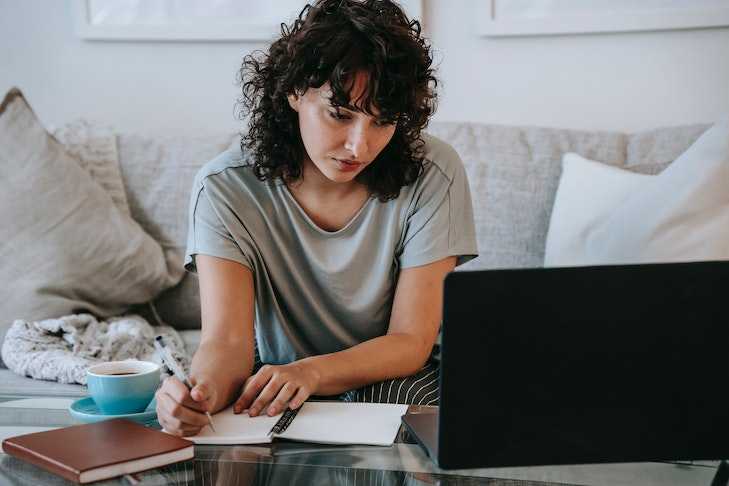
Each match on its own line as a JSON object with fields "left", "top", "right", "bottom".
{"left": 0, "top": 395, "right": 718, "bottom": 486}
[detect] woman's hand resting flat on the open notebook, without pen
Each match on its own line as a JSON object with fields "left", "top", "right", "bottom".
{"left": 233, "top": 361, "right": 319, "bottom": 417}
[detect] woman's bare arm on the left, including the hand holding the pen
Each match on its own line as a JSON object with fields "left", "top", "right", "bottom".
{"left": 157, "top": 255, "right": 254, "bottom": 435}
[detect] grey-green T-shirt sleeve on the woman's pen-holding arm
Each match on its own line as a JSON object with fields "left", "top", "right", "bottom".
{"left": 185, "top": 184, "right": 253, "bottom": 272}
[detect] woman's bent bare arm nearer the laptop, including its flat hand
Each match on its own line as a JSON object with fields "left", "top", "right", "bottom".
{"left": 236, "top": 257, "right": 456, "bottom": 415}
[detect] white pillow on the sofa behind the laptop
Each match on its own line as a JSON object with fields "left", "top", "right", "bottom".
{"left": 544, "top": 118, "right": 729, "bottom": 266}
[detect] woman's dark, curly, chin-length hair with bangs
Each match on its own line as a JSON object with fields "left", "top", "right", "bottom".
{"left": 238, "top": 0, "right": 438, "bottom": 202}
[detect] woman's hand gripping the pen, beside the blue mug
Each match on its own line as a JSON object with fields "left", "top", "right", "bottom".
{"left": 155, "top": 376, "right": 215, "bottom": 436}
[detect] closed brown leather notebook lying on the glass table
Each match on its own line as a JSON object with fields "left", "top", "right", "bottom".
{"left": 2, "top": 419, "right": 195, "bottom": 483}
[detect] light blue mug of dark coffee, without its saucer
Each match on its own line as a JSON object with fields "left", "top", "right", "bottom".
{"left": 86, "top": 360, "right": 160, "bottom": 415}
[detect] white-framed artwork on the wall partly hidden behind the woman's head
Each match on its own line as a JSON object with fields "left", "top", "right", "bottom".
{"left": 72, "top": 0, "right": 422, "bottom": 41}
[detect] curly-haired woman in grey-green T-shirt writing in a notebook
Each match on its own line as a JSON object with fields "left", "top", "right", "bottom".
{"left": 157, "top": 0, "right": 476, "bottom": 435}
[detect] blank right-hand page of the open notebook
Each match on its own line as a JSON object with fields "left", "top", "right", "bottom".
{"left": 277, "top": 402, "right": 408, "bottom": 446}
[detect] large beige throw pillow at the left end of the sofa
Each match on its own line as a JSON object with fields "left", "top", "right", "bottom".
{"left": 0, "top": 89, "right": 183, "bottom": 344}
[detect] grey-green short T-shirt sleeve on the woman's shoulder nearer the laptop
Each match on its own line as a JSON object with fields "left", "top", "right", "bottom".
{"left": 400, "top": 144, "right": 478, "bottom": 268}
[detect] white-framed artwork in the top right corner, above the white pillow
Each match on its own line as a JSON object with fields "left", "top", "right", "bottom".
{"left": 477, "top": 0, "right": 729, "bottom": 37}
